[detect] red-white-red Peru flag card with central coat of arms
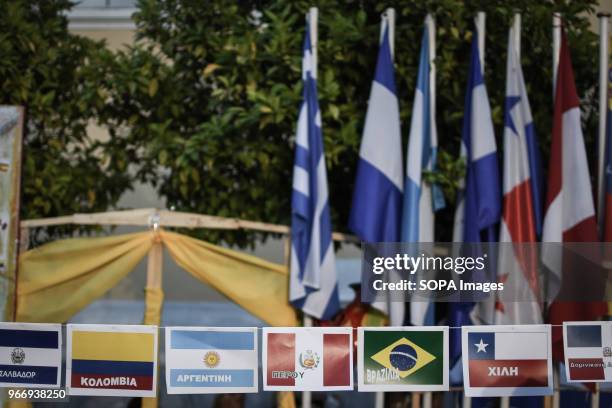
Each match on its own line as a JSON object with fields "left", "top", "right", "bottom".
{"left": 262, "top": 327, "right": 353, "bottom": 391}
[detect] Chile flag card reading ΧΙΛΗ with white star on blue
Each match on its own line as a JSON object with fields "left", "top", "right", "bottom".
{"left": 461, "top": 324, "right": 553, "bottom": 397}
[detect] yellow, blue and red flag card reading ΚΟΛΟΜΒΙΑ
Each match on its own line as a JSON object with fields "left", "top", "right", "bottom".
{"left": 66, "top": 324, "right": 157, "bottom": 397}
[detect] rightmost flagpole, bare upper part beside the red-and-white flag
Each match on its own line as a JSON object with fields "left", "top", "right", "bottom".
{"left": 597, "top": 13, "right": 610, "bottom": 232}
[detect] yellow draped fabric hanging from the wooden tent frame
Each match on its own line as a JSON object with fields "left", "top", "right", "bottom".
{"left": 16, "top": 230, "right": 297, "bottom": 326}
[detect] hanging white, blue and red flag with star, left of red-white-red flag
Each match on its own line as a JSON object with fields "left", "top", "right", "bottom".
{"left": 498, "top": 28, "right": 542, "bottom": 324}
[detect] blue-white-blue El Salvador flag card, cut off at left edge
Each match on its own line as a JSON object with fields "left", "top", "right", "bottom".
{"left": 0, "top": 322, "right": 62, "bottom": 388}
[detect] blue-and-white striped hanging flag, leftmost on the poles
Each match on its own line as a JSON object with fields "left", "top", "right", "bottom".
{"left": 289, "top": 24, "right": 340, "bottom": 320}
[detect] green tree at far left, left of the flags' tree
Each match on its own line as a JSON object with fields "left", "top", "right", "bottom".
{"left": 0, "top": 0, "right": 130, "bottom": 242}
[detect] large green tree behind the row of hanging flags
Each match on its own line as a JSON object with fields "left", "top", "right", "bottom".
{"left": 124, "top": 0, "right": 597, "bottom": 244}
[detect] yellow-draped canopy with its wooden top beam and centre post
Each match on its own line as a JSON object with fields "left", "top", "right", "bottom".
{"left": 9, "top": 209, "right": 355, "bottom": 407}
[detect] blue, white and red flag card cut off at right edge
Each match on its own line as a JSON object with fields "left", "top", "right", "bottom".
{"left": 563, "top": 322, "right": 612, "bottom": 382}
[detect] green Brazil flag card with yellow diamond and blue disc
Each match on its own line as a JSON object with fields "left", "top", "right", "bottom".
{"left": 357, "top": 326, "right": 448, "bottom": 391}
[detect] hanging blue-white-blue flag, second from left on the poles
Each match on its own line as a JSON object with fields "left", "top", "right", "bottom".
{"left": 349, "top": 17, "right": 405, "bottom": 325}
